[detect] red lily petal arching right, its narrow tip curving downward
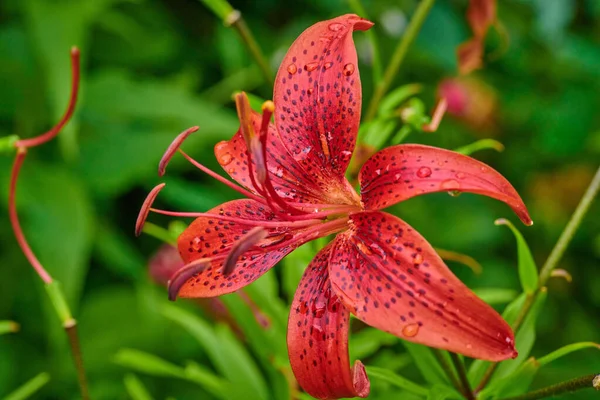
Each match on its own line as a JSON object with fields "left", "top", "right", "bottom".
{"left": 359, "top": 144, "right": 533, "bottom": 225}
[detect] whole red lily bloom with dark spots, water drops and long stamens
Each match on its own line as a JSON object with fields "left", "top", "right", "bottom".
{"left": 137, "top": 15, "right": 531, "bottom": 399}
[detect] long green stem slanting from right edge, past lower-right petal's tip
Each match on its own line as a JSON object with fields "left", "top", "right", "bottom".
{"left": 475, "top": 167, "right": 600, "bottom": 393}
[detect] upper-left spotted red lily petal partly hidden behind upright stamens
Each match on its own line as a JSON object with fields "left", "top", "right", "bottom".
{"left": 215, "top": 111, "right": 326, "bottom": 203}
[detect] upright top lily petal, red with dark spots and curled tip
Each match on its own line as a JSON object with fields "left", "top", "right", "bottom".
{"left": 273, "top": 14, "right": 373, "bottom": 203}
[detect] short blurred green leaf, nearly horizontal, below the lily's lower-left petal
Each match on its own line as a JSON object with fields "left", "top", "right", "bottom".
{"left": 113, "top": 349, "right": 185, "bottom": 378}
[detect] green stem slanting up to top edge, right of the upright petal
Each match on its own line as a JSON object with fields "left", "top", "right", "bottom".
{"left": 365, "top": 0, "right": 435, "bottom": 121}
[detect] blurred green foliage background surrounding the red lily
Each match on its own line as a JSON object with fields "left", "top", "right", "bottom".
{"left": 0, "top": 0, "right": 600, "bottom": 399}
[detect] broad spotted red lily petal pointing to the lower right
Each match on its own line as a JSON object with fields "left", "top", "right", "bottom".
{"left": 329, "top": 211, "right": 517, "bottom": 361}
